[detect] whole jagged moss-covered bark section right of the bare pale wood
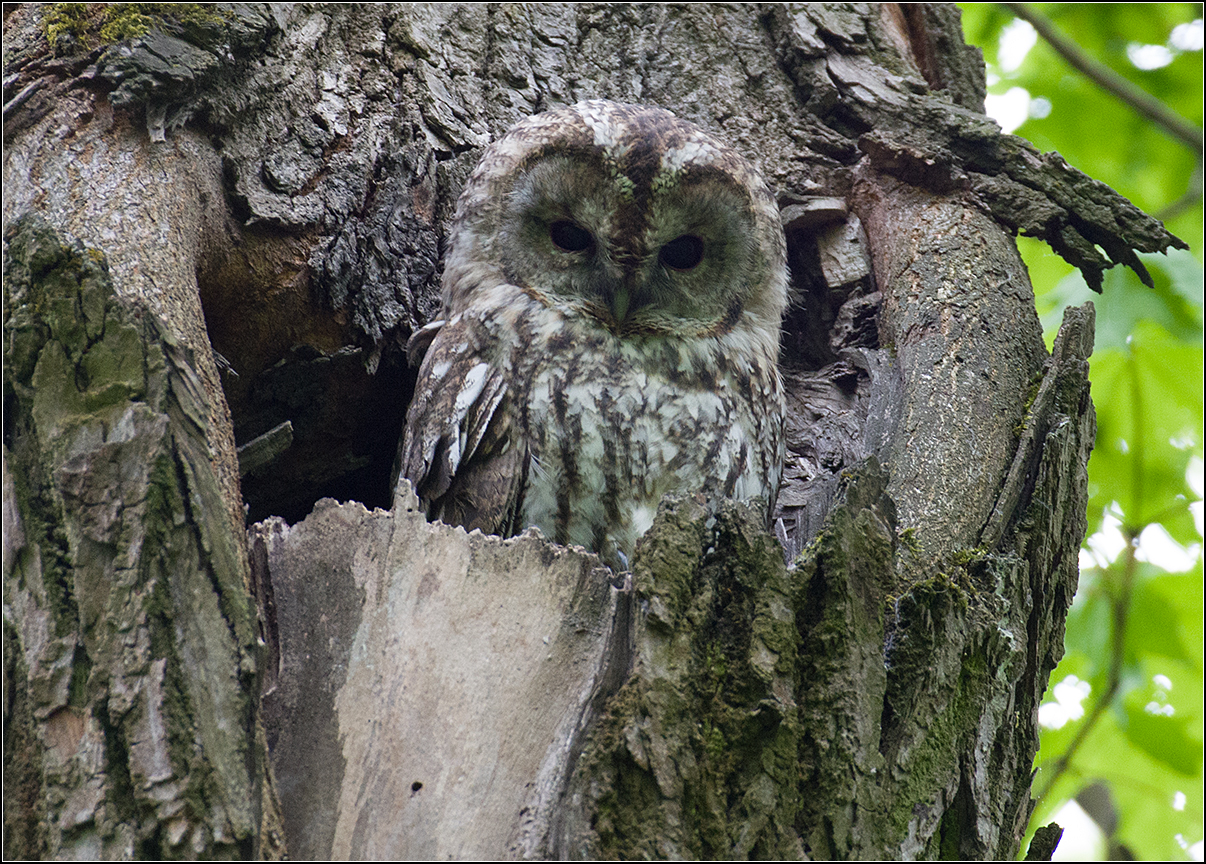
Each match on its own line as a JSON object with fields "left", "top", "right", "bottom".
{"left": 569, "top": 460, "right": 1056, "bottom": 859}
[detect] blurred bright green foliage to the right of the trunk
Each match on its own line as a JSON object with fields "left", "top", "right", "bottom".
{"left": 959, "top": 4, "right": 1202, "bottom": 860}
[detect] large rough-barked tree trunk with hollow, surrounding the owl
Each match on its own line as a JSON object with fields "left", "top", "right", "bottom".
{"left": 4, "top": 4, "right": 1179, "bottom": 858}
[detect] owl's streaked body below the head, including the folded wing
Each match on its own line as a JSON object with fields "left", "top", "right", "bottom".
{"left": 398, "top": 296, "right": 783, "bottom": 567}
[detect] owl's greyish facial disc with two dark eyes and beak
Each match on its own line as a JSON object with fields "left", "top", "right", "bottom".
{"left": 493, "top": 153, "right": 756, "bottom": 337}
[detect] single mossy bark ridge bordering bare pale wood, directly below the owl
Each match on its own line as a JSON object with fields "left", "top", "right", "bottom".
{"left": 564, "top": 498, "right": 802, "bottom": 858}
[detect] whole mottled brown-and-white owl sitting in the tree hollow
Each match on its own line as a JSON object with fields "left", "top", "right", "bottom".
{"left": 397, "top": 101, "right": 788, "bottom": 570}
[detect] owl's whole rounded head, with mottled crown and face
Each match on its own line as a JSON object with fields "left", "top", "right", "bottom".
{"left": 444, "top": 100, "right": 788, "bottom": 348}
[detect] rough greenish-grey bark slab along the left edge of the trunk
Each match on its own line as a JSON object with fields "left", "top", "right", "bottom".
{"left": 5, "top": 216, "right": 279, "bottom": 858}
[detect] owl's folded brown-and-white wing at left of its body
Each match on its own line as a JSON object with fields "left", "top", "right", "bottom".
{"left": 398, "top": 319, "right": 528, "bottom": 537}
